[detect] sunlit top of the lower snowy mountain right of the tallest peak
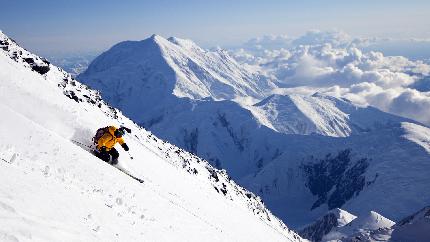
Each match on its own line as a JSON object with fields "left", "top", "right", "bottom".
{"left": 249, "top": 93, "right": 404, "bottom": 137}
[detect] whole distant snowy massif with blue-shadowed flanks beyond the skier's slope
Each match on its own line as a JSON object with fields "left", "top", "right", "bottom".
{"left": 78, "top": 36, "right": 430, "bottom": 231}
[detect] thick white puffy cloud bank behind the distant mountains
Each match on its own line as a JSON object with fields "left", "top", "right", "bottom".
{"left": 231, "top": 31, "right": 430, "bottom": 125}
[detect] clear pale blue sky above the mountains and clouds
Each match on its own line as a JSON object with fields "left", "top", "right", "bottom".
{"left": 0, "top": 0, "right": 430, "bottom": 54}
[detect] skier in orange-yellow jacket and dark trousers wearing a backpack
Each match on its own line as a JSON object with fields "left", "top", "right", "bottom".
{"left": 94, "top": 126, "right": 131, "bottom": 165}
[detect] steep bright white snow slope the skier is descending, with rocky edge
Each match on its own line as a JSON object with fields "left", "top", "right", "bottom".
{"left": 0, "top": 32, "right": 302, "bottom": 241}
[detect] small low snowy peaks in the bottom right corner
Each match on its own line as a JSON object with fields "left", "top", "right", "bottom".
{"left": 299, "top": 207, "right": 430, "bottom": 242}
